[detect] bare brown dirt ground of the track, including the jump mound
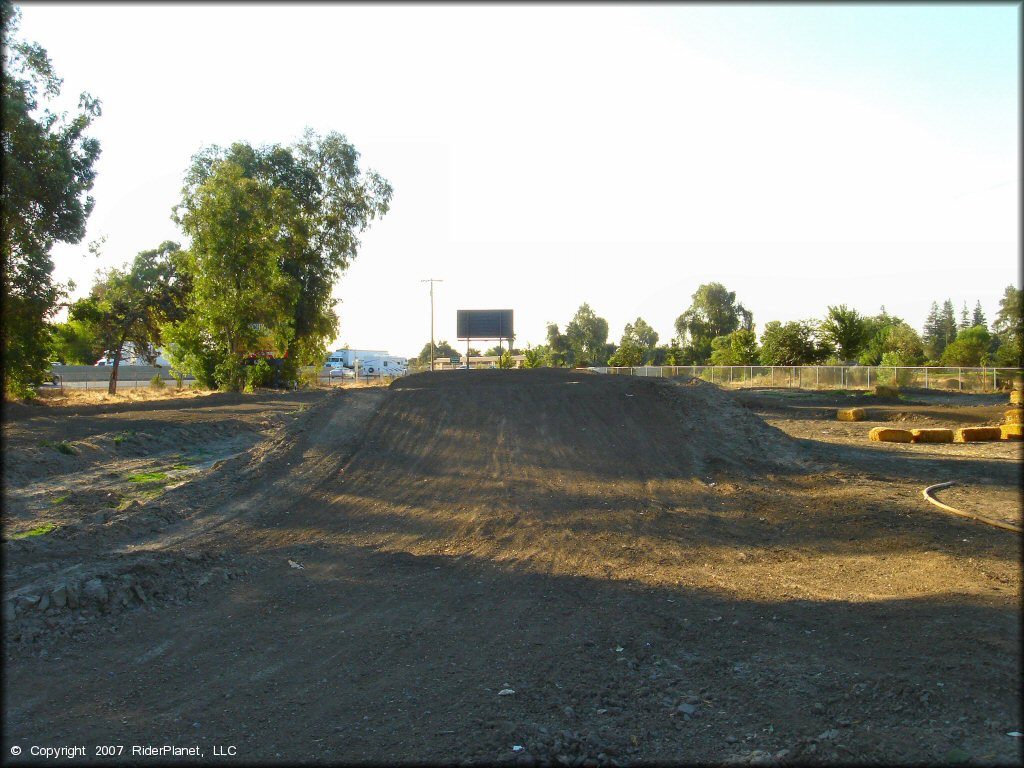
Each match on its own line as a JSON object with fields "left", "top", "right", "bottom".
{"left": 3, "top": 370, "right": 1024, "bottom": 765}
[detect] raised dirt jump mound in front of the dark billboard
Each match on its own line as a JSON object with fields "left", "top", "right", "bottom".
{"left": 378, "top": 369, "right": 801, "bottom": 480}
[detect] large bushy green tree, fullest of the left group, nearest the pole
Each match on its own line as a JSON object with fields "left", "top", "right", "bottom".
{"left": 167, "top": 129, "right": 392, "bottom": 387}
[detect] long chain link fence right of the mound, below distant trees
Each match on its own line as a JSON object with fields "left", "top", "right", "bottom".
{"left": 592, "top": 366, "right": 1024, "bottom": 392}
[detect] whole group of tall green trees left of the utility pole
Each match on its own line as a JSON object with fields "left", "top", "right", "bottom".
{"left": 0, "top": 0, "right": 392, "bottom": 396}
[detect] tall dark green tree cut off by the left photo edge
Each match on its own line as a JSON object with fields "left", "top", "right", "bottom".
{"left": 0, "top": 0, "right": 100, "bottom": 395}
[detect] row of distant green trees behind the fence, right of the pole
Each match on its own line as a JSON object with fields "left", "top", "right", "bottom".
{"left": 418, "top": 283, "right": 1024, "bottom": 376}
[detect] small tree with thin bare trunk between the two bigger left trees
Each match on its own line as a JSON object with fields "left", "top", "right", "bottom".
{"left": 69, "top": 242, "right": 182, "bottom": 394}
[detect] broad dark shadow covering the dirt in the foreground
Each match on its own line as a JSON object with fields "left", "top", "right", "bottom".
{"left": 12, "top": 544, "right": 1020, "bottom": 765}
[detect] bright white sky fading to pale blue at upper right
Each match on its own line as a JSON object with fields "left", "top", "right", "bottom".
{"left": 17, "top": 2, "right": 1021, "bottom": 356}
